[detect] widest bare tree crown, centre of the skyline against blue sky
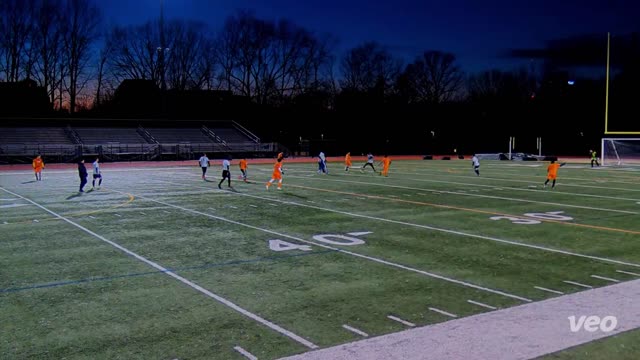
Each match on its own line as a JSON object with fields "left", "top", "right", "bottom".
{"left": 214, "top": 12, "right": 332, "bottom": 104}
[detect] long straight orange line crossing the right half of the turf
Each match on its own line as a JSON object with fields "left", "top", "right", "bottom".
{"left": 289, "top": 180, "right": 640, "bottom": 235}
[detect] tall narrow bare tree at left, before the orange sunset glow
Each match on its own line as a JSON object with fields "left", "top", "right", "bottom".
{"left": 63, "top": 0, "right": 101, "bottom": 113}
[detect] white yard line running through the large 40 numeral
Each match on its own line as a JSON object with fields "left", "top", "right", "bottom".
{"left": 111, "top": 189, "right": 532, "bottom": 302}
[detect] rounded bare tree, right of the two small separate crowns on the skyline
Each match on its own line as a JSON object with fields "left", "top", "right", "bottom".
{"left": 404, "top": 51, "right": 463, "bottom": 104}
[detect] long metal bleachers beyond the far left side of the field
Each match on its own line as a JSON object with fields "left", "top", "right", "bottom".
{"left": 0, "top": 119, "right": 281, "bottom": 163}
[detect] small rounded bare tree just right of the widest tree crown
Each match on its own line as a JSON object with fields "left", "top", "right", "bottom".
{"left": 341, "top": 42, "right": 401, "bottom": 94}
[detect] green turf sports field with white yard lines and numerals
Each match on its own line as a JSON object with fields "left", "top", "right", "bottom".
{"left": 0, "top": 160, "right": 640, "bottom": 359}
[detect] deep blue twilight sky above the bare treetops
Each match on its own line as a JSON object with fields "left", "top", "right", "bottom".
{"left": 99, "top": 0, "right": 640, "bottom": 72}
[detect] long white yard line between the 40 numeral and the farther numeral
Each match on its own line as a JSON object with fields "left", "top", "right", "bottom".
{"left": 151, "top": 180, "right": 640, "bottom": 268}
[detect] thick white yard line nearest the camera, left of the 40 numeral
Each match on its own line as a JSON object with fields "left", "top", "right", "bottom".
{"left": 0, "top": 187, "right": 318, "bottom": 349}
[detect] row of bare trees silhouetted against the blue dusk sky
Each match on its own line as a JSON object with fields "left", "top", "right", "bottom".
{"left": 0, "top": 0, "right": 596, "bottom": 112}
